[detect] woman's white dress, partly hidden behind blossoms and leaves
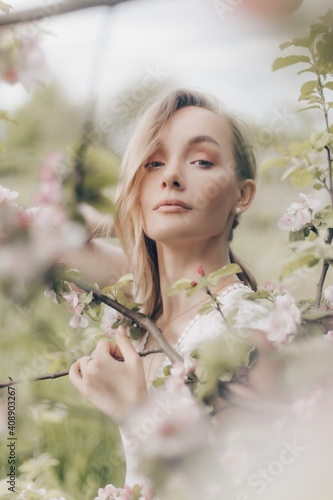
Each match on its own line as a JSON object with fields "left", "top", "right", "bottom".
{"left": 119, "top": 283, "right": 269, "bottom": 486}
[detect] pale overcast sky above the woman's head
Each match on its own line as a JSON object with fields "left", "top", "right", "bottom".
{"left": 0, "top": 0, "right": 328, "bottom": 124}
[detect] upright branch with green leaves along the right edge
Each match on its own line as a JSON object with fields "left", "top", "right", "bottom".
{"left": 262, "top": 9, "right": 333, "bottom": 308}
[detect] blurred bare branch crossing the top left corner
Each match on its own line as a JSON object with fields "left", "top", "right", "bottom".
{"left": 0, "top": 0, "right": 127, "bottom": 26}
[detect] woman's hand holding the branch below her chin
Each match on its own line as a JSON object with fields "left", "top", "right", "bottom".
{"left": 69, "top": 326, "right": 147, "bottom": 424}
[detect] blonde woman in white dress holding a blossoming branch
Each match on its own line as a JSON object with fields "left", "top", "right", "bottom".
{"left": 69, "top": 90, "right": 274, "bottom": 488}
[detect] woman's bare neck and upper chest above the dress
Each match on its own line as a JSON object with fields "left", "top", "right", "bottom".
{"left": 156, "top": 237, "right": 238, "bottom": 322}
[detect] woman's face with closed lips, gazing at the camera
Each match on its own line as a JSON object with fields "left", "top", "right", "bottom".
{"left": 139, "top": 106, "right": 252, "bottom": 243}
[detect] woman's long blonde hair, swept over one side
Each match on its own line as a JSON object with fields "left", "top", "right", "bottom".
{"left": 114, "top": 89, "right": 257, "bottom": 319}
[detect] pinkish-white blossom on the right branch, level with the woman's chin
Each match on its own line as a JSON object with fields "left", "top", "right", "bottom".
{"left": 277, "top": 193, "right": 319, "bottom": 231}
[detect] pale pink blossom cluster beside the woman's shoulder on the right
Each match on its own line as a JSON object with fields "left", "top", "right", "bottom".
{"left": 258, "top": 292, "right": 301, "bottom": 346}
